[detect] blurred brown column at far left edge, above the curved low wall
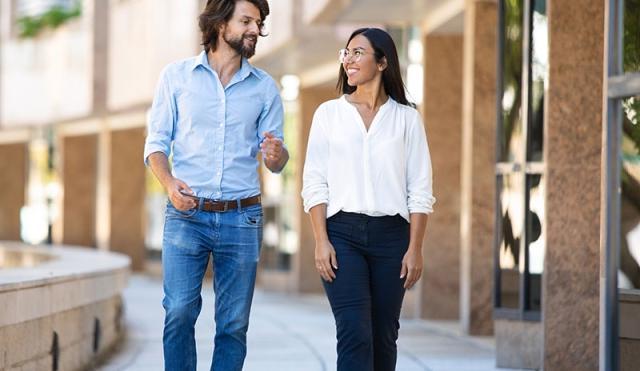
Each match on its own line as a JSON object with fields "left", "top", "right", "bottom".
{"left": 0, "top": 143, "right": 28, "bottom": 241}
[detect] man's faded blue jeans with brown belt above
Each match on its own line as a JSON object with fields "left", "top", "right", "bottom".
{"left": 162, "top": 202, "right": 262, "bottom": 371}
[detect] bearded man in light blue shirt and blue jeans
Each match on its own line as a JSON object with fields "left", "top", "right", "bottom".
{"left": 144, "top": 0, "right": 289, "bottom": 371}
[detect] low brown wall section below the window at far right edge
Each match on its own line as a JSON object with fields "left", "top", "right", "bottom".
{"left": 620, "top": 289, "right": 640, "bottom": 371}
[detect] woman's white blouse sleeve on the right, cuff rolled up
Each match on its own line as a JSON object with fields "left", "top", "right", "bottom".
{"left": 405, "top": 112, "right": 436, "bottom": 214}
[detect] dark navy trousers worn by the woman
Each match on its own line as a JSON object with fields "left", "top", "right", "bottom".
{"left": 323, "top": 212, "right": 409, "bottom": 371}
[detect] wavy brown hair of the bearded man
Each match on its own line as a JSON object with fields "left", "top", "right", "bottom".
{"left": 198, "top": 0, "right": 269, "bottom": 53}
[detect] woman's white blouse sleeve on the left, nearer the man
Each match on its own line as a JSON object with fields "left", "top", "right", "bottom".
{"left": 302, "top": 106, "right": 329, "bottom": 213}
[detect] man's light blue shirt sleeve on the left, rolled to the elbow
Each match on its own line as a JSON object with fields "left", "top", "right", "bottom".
{"left": 144, "top": 66, "right": 177, "bottom": 165}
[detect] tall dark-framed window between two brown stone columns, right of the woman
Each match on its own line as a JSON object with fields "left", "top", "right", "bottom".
{"left": 495, "top": 0, "right": 548, "bottom": 320}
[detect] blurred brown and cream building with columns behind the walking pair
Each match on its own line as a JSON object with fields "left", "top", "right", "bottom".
{"left": 0, "top": 0, "right": 640, "bottom": 370}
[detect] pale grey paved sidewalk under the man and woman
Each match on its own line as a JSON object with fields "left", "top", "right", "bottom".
{"left": 98, "top": 276, "right": 520, "bottom": 371}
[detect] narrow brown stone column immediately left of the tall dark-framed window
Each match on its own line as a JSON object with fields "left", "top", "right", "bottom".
{"left": 460, "top": 0, "right": 498, "bottom": 335}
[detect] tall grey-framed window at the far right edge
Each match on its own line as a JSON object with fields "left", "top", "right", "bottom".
{"left": 600, "top": 0, "right": 640, "bottom": 371}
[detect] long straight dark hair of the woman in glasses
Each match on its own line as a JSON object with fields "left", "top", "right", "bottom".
{"left": 336, "top": 28, "right": 415, "bottom": 107}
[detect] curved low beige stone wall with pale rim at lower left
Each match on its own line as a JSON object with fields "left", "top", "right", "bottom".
{"left": 0, "top": 243, "right": 130, "bottom": 371}
